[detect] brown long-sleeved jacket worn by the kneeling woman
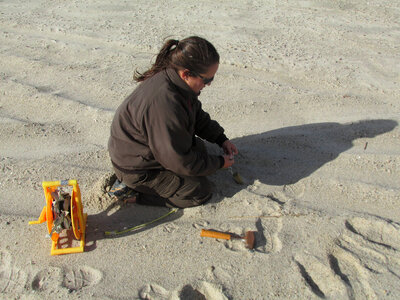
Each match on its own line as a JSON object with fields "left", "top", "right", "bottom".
{"left": 108, "top": 69, "right": 227, "bottom": 176}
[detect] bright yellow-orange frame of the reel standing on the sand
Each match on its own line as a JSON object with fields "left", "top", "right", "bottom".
{"left": 29, "top": 180, "right": 87, "bottom": 255}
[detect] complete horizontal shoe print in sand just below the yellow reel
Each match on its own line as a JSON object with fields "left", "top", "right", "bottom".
{"left": 32, "top": 266, "right": 102, "bottom": 292}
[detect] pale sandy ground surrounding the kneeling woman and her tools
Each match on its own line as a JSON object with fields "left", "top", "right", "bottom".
{"left": 0, "top": 0, "right": 400, "bottom": 299}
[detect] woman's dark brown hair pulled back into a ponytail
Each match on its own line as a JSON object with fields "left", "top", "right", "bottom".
{"left": 133, "top": 36, "right": 219, "bottom": 82}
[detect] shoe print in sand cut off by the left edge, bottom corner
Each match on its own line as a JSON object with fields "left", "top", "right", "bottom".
{"left": 0, "top": 251, "right": 27, "bottom": 295}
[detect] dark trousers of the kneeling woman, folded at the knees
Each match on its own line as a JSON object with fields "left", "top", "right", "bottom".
{"left": 114, "top": 138, "right": 212, "bottom": 208}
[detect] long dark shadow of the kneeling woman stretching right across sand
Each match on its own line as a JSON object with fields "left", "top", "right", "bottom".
{"left": 211, "top": 119, "right": 398, "bottom": 197}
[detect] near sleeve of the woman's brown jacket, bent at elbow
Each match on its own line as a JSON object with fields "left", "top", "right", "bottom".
{"left": 143, "top": 95, "right": 221, "bottom": 176}
